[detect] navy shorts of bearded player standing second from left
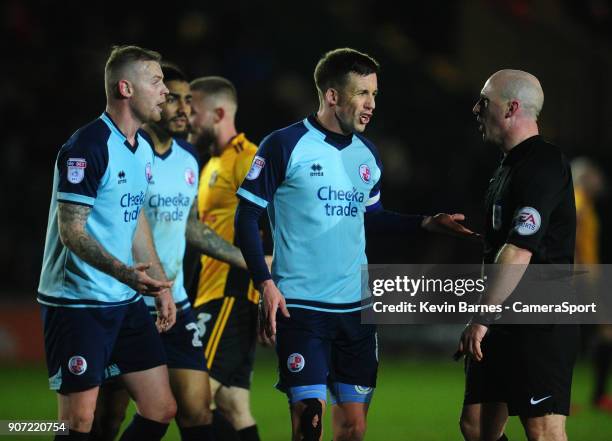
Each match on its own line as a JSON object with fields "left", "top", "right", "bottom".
{"left": 160, "top": 308, "right": 208, "bottom": 371}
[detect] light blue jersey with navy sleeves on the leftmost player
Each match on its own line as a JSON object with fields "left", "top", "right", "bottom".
{"left": 38, "top": 113, "right": 153, "bottom": 307}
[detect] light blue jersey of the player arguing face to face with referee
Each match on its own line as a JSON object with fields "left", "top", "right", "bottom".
{"left": 238, "top": 115, "right": 382, "bottom": 312}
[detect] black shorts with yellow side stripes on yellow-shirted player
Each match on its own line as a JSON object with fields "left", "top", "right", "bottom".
{"left": 194, "top": 297, "right": 257, "bottom": 389}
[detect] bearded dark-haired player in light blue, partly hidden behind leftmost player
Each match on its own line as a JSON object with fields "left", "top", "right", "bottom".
{"left": 91, "top": 64, "right": 246, "bottom": 441}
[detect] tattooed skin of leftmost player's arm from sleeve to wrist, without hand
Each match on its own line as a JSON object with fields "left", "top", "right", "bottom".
{"left": 58, "top": 202, "right": 136, "bottom": 285}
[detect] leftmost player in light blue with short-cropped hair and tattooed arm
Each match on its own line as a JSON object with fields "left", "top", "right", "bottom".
{"left": 38, "top": 46, "right": 176, "bottom": 440}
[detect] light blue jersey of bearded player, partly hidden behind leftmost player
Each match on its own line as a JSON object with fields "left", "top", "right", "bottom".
{"left": 144, "top": 136, "right": 199, "bottom": 309}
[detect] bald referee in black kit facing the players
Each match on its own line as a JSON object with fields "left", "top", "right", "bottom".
{"left": 459, "top": 70, "right": 579, "bottom": 441}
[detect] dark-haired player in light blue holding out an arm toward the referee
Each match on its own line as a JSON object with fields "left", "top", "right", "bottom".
{"left": 236, "top": 48, "right": 473, "bottom": 440}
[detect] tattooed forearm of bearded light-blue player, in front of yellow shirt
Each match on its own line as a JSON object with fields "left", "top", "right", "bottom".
{"left": 186, "top": 199, "right": 247, "bottom": 269}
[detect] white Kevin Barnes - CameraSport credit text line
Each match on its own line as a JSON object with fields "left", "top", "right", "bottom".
{"left": 372, "top": 302, "right": 597, "bottom": 315}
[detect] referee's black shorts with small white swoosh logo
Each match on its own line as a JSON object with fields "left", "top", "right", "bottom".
{"left": 463, "top": 325, "right": 580, "bottom": 418}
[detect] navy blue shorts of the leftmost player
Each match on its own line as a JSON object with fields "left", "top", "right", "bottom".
{"left": 41, "top": 299, "right": 166, "bottom": 394}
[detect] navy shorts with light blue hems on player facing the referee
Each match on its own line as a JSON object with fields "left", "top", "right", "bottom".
{"left": 276, "top": 308, "right": 378, "bottom": 404}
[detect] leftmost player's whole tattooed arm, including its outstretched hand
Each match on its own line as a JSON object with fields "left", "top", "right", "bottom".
{"left": 58, "top": 202, "right": 171, "bottom": 295}
